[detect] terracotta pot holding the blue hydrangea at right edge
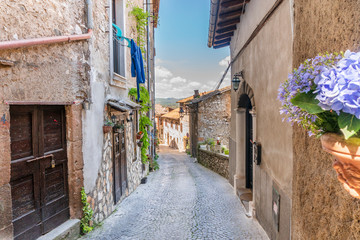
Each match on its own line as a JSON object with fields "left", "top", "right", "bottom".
{"left": 321, "top": 133, "right": 360, "bottom": 198}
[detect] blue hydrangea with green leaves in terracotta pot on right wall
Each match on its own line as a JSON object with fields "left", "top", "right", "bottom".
{"left": 278, "top": 50, "right": 360, "bottom": 198}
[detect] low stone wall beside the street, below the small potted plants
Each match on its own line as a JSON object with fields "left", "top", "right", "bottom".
{"left": 197, "top": 149, "right": 229, "bottom": 180}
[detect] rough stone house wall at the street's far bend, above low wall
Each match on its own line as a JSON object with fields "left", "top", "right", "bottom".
{"left": 198, "top": 90, "right": 231, "bottom": 148}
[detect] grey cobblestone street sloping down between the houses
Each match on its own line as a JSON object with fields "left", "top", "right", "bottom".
{"left": 82, "top": 147, "right": 268, "bottom": 240}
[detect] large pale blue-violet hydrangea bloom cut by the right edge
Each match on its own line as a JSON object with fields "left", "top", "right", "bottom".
{"left": 314, "top": 50, "right": 360, "bottom": 119}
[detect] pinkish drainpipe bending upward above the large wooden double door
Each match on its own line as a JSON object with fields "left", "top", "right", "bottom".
{"left": 0, "top": 0, "right": 93, "bottom": 50}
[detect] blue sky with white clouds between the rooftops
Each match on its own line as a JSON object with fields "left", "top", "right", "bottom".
{"left": 155, "top": 0, "right": 230, "bottom": 98}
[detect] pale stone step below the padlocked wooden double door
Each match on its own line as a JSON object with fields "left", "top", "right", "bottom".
{"left": 37, "top": 219, "right": 80, "bottom": 240}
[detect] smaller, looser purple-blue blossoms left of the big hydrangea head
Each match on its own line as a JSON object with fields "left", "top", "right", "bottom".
{"left": 278, "top": 54, "right": 341, "bottom": 135}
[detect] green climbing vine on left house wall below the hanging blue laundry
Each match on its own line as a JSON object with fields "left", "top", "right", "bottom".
{"left": 129, "top": 86, "right": 152, "bottom": 163}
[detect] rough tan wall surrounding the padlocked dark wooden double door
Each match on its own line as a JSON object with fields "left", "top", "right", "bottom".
{"left": 0, "top": 0, "right": 89, "bottom": 236}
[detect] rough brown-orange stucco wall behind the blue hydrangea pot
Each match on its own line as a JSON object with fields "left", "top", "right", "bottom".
{"left": 292, "top": 0, "right": 360, "bottom": 239}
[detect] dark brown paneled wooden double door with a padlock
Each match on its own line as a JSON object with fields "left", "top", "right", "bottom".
{"left": 10, "top": 106, "right": 69, "bottom": 239}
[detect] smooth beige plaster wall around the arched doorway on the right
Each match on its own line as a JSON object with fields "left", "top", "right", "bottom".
{"left": 230, "top": 0, "right": 293, "bottom": 239}
